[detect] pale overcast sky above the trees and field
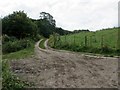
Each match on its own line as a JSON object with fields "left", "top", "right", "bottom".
{"left": 0, "top": 0, "right": 119, "bottom": 31}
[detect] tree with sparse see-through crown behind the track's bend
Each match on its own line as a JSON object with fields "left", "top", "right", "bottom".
{"left": 35, "top": 12, "right": 56, "bottom": 38}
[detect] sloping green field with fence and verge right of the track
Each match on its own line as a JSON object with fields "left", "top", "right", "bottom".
{"left": 50, "top": 28, "right": 118, "bottom": 55}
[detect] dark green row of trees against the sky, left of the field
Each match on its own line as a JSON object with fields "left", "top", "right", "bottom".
{"left": 2, "top": 11, "right": 71, "bottom": 39}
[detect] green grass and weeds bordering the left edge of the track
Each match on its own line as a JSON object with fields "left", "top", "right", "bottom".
{"left": 2, "top": 44, "right": 34, "bottom": 90}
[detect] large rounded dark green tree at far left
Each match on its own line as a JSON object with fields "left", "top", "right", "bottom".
{"left": 2, "top": 11, "right": 37, "bottom": 39}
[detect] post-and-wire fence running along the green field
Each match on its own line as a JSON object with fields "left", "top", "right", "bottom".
{"left": 54, "top": 34, "right": 118, "bottom": 50}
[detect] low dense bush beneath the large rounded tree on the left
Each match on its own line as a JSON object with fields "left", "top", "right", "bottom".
{"left": 2, "top": 36, "right": 33, "bottom": 54}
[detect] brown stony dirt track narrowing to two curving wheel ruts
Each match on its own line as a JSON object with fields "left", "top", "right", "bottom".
{"left": 11, "top": 41, "right": 118, "bottom": 88}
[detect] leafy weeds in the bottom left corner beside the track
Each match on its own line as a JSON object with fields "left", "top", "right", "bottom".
{"left": 2, "top": 60, "right": 30, "bottom": 90}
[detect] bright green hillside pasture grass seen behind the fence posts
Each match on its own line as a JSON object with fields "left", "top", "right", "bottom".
{"left": 61, "top": 29, "right": 118, "bottom": 49}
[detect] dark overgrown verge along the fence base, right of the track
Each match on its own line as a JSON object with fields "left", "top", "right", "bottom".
{"left": 48, "top": 37, "right": 120, "bottom": 57}
